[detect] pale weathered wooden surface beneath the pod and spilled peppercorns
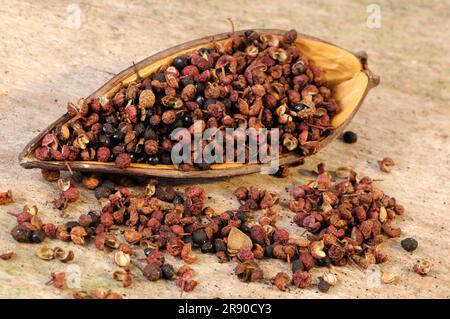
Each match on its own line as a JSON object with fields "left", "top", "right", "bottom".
{"left": 0, "top": 0, "right": 450, "bottom": 298}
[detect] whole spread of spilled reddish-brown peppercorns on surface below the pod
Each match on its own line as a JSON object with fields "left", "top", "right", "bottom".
{"left": 6, "top": 164, "right": 414, "bottom": 292}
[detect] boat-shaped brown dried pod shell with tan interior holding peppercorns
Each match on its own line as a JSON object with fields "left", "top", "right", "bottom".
{"left": 19, "top": 29, "right": 380, "bottom": 179}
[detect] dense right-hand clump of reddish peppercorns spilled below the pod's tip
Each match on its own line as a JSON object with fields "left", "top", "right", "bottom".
{"left": 289, "top": 164, "right": 403, "bottom": 270}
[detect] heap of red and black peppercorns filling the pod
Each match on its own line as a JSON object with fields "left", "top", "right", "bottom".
{"left": 35, "top": 30, "right": 339, "bottom": 170}
